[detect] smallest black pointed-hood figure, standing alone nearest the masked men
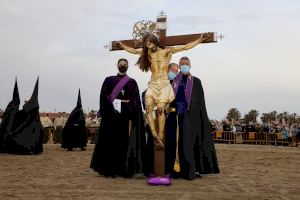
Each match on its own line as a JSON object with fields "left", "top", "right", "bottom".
{"left": 61, "top": 90, "right": 87, "bottom": 151}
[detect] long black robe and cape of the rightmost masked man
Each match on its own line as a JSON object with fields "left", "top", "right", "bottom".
{"left": 165, "top": 77, "right": 219, "bottom": 180}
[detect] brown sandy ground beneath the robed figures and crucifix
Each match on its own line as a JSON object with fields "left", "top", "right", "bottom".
{"left": 0, "top": 144, "right": 300, "bottom": 200}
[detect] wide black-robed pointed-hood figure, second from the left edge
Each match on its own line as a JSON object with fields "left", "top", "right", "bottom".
{"left": 6, "top": 79, "right": 44, "bottom": 154}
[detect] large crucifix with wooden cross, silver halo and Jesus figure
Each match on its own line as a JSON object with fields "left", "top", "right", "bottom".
{"left": 110, "top": 13, "right": 216, "bottom": 182}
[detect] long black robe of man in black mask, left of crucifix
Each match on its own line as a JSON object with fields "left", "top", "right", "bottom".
{"left": 90, "top": 75, "right": 145, "bottom": 177}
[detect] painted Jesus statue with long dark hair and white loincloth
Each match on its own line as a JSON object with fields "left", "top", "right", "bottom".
{"left": 119, "top": 33, "right": 207, "bottom": 146}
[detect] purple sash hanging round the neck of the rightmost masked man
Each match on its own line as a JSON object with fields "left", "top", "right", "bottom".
{"left": 172, "top": 73, "right": 193, "bottom": 107}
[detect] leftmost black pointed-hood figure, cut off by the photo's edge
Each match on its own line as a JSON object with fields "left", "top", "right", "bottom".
{"left": 0, "top": 79, "right": 20, "bottom": 153}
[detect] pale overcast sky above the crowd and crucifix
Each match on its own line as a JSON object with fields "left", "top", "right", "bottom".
{"left": 0, "top": 0, "right": 300, "bottom": 119}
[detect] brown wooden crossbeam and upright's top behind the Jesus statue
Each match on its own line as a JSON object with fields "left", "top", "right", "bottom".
{"left": 109, "top": 14, "right": 217, "bottom": 51}
